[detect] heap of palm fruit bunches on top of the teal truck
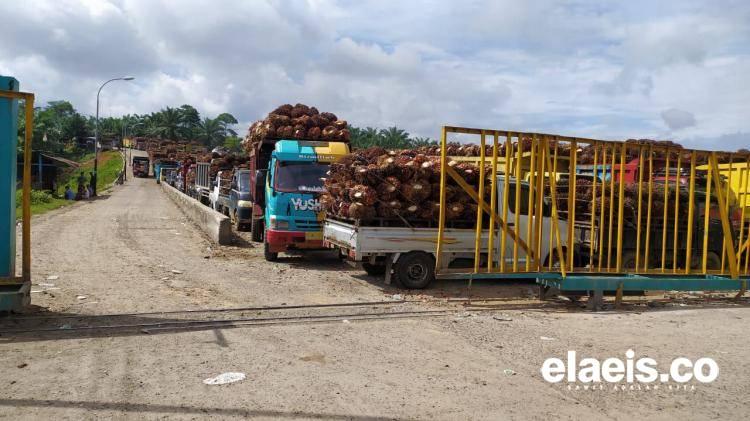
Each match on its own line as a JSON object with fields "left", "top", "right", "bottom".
{"left": 243, "top": 104, "right": 349, "bottom": 152}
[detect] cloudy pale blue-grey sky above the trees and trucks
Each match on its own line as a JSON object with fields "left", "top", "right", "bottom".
{"left": 0, "top": 0, "right": 750, "bottom": 150}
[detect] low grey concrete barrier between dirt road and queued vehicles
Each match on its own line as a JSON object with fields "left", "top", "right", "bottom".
{"left": 159, "top": 183, "right": 232, "bottom": 244}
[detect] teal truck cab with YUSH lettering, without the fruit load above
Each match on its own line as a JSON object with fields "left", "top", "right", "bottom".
{"left": 250, "top": 139, "right": 349, "bottom": 261}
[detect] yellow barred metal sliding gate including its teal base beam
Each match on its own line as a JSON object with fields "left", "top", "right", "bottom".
{"left": 435, "top": 126, "right": 750, "bottom": 300}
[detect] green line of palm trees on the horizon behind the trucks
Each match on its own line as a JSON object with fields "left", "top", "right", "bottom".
{"left": 18, "top": 101, "right": 435, "bottom": 155}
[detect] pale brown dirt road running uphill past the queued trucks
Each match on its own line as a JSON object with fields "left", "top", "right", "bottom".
{"left": 0, "top": 153, "right": 750, "bottom": 420}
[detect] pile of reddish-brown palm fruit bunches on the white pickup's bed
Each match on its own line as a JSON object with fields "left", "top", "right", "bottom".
{"left": 321, "top": 147, "right": 489, "bottom": 222}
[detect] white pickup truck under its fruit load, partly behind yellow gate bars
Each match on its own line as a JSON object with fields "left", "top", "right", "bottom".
{"left": 323, "top": 175, "right": 567, "bottom": 288}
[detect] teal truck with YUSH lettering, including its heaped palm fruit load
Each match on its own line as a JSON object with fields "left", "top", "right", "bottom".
{"left": 243, "top": 104, "right": 356, "bottom": 261}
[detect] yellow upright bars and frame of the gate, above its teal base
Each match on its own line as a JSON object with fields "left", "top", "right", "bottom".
{"left": 436, "top": 126, "right": 750, "bottom": 279}
